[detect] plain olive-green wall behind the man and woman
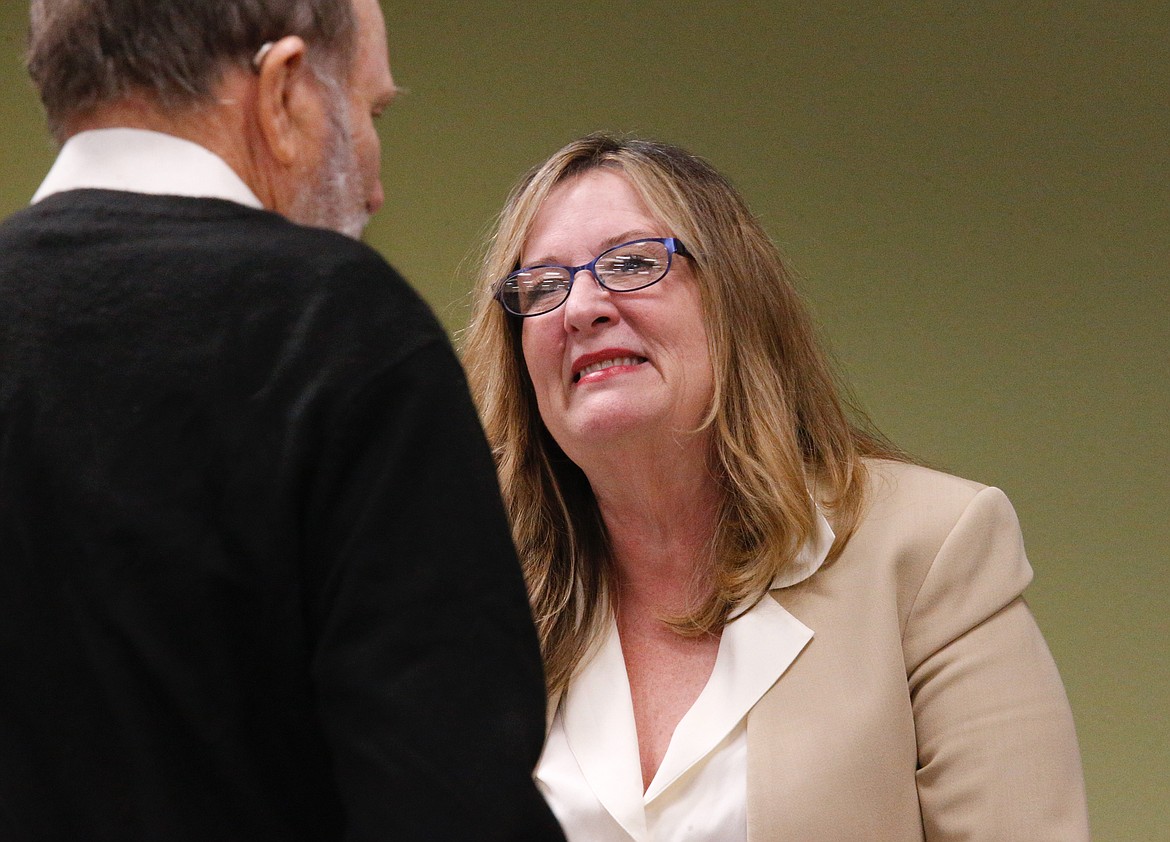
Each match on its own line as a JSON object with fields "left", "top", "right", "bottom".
{"left": 0, "top": 0, "right": 1170, "bottom": 842}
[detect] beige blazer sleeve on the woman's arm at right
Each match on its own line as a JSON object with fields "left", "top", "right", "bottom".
{"left": 903, "top": 488, "right": 1089, "bottom": 842}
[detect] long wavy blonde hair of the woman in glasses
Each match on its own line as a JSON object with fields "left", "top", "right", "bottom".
{"left": 462, "top": 133, "right": 903, "bottom": 692}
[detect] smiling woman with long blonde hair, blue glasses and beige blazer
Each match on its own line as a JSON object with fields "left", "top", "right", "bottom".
{"left": 463, "top": 134, "right": 1088, "bottom": 842}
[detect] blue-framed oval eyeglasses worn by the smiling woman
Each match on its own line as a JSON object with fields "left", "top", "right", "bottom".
{"left": 495, "top": 237, "right": 690, "bottom": 317}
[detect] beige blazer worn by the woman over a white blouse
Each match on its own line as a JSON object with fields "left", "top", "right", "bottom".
{"left": 748, "top": 462, "right": 1089, "bottom": 842}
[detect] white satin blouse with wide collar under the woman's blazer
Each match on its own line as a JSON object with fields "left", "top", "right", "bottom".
{"left": 536, "top": 516, "right": 834, "bottom": 842}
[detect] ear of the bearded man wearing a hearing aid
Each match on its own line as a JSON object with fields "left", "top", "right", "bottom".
{"left": 255, "top": 35, "right": 321, "bottom": 166}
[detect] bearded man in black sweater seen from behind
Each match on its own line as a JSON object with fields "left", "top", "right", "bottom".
{"left": 0, "top": 0, "right": 563, "bottom": 842}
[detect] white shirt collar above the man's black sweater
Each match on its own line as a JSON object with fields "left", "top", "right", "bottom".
{"left": 33, "top": 129, "right": 262, "bottom": 208}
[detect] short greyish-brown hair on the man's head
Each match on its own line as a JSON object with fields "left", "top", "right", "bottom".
{"left": 27, "top": 0, "right": 356, "bottom": 139}
